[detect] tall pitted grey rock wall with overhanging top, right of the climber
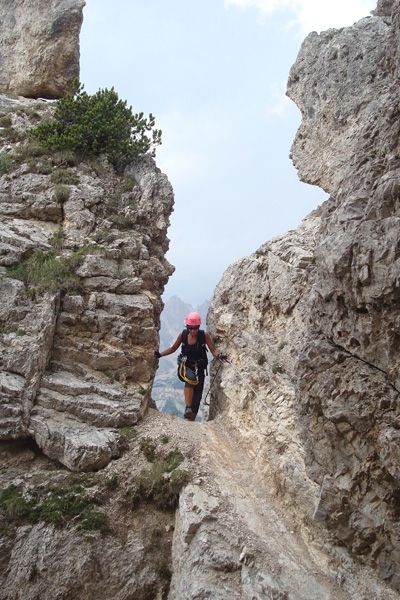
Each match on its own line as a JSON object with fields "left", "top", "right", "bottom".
{"left": 208, "top": 1, "right": 400, "bottom": 590}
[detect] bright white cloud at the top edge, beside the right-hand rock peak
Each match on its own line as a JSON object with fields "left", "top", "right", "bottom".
{"left": 224, "top": 0, "right": 377, "bottom": 34}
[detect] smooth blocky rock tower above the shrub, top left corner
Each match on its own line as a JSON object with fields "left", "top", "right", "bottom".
{"left": 0, "top": 0, "right": 85, "bottom": 98}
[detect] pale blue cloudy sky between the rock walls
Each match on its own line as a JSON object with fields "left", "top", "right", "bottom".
{"left": 80, "top": 0, "right": 377, "bottom": 307}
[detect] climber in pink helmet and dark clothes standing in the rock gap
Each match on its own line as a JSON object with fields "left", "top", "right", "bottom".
{"left": 154, "top": 312, "right": 228, "bottom": 421}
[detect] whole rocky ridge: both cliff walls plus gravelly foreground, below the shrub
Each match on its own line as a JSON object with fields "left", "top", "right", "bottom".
{"left": 0, "top": 0, "right": 399, "bottom": 600}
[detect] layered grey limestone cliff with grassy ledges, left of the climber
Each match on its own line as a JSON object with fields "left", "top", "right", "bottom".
{"left": 0, "top": 97, "right": 173, "bottom": 471}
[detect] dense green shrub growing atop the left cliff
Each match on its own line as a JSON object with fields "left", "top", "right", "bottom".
{"left": 30, "top": 82, "right": 161, "bottom": 173}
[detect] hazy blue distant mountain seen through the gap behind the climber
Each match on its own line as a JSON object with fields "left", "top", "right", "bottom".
{"left": 152, "top": 296, "right": 210, "bottom": 415}
